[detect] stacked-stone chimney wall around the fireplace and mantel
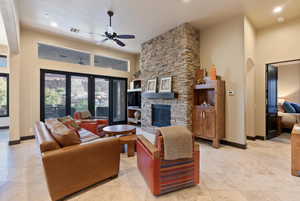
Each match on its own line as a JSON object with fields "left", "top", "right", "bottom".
{"left": 140, "top": 23, "right": 200, "bottom": 132}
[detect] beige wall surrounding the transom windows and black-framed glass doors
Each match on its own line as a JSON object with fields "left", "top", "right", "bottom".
{"left": 10, "top": 27, "right": 136, "bottom": 139}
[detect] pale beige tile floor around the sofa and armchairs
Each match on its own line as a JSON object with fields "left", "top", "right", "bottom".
{"left": 0, "top": 131, "right": 300, "bottom": 201}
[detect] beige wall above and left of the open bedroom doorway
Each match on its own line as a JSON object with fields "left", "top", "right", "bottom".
{"left": 255, "top": 19, "right": 300, "bottom": 136}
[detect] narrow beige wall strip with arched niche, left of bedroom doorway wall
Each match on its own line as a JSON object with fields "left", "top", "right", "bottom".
{"left": 244, "top": 17, "right": 256, "bottom": 137}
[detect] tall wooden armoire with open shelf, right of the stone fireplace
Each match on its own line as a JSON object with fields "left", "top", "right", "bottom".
{"left": 192, "top": 80, "right": 225, "bottom": 148}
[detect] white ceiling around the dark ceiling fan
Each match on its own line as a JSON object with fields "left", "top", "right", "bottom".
{"left": 20, "top": 0, "right": 300, "bottom": 53}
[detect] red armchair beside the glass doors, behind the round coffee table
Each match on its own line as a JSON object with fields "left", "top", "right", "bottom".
{"left": 74, "top": 112, "right": 109, "bottom": 137}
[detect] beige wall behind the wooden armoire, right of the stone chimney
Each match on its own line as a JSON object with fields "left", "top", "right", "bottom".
{"left": 200, "top": 16, "right": 246, "bottom": 144}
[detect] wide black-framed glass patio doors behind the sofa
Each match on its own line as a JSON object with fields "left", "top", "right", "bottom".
{"left": 40, "top": 70, "right": 127, "bottom": 124}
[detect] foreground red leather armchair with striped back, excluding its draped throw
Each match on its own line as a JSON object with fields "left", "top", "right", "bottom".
{"left": 136, "top": 131, "right": 200, "bottom": 195}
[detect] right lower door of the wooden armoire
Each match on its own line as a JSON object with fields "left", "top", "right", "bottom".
{"left": 204, "top": 110, "right": 216, "bottom": 138}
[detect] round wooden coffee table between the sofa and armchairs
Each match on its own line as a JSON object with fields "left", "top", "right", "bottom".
{"left": 103, "top": 125, "right": 136, "bottom": 157}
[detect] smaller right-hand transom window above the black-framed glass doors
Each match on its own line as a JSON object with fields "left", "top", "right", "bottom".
{"left": 94, "top": 55, "right": 129, "bottom": 72}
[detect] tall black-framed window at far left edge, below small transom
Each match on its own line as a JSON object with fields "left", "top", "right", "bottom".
{"left": 0, "top": 74, "right": 9, "bottom": 117}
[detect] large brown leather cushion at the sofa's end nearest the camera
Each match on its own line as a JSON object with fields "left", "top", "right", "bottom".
{"left": 46, "top": 119, "right": 81, "bottom": 147}
